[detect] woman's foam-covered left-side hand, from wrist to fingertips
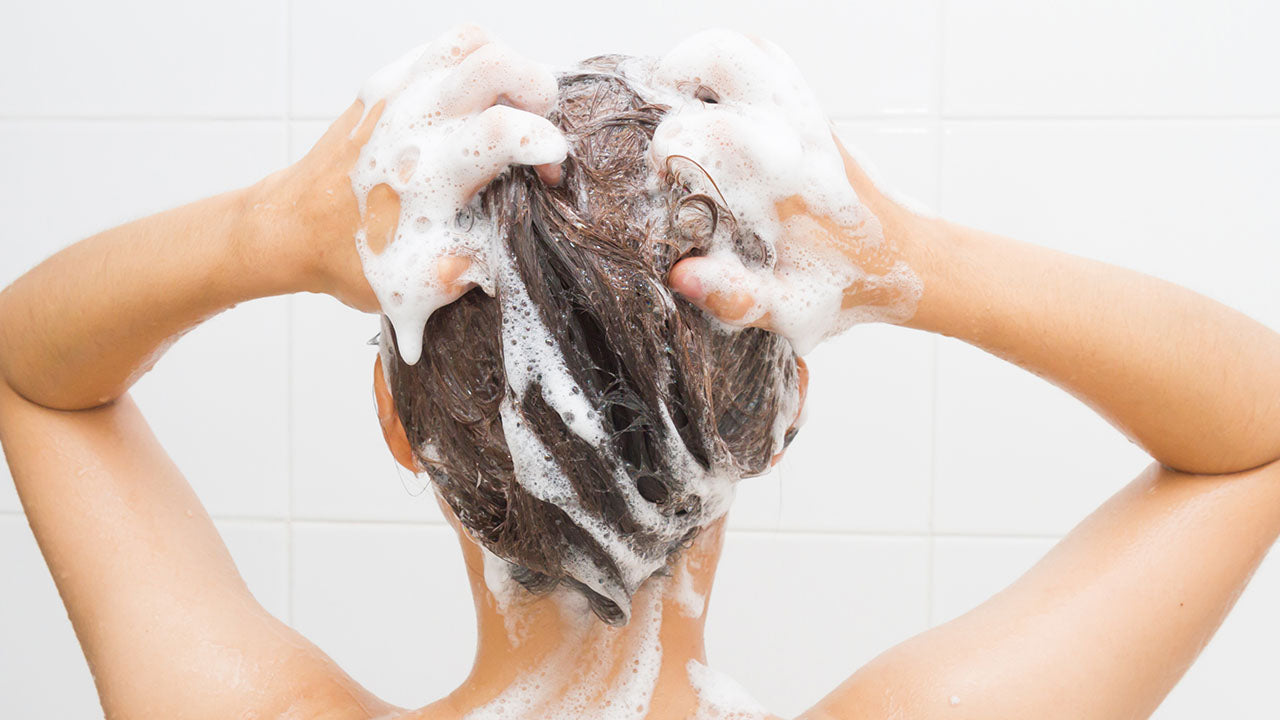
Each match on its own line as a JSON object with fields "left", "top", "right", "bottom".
{"left": 248, "top": 26, "right": 563, "bottom": 313}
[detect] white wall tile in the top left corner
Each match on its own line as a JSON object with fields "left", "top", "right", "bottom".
{"left": 0, "top": 0, "right": 285, "bottom": 117}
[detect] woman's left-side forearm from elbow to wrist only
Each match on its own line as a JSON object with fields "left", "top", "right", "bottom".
{"left": 0, "top": 184, "right": 289, "bottom": 410}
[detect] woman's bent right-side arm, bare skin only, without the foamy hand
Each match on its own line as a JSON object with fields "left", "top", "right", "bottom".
{"left": 788, "top": 169, "right": 1280, "bottom": 720}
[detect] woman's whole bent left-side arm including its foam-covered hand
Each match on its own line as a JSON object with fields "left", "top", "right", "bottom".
{"left": 0, "top": 27, "right": 563, "bottom": 719}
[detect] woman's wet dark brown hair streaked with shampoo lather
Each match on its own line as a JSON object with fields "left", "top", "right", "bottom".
{"left": 384, "top": 56, "right": 796, "bottom": 624}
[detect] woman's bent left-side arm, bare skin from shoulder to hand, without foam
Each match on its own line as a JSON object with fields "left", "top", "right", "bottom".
{"left": 0, "top": 105, "right": 399, "bottom": 717}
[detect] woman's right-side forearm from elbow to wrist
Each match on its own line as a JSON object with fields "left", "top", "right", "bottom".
{"left": 908, "top": 222, "right": 1280, "bottom": 473}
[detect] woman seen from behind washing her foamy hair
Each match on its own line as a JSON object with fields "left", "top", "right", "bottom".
{"left": 0, "top": 29, "right": 1280, "bottom": 719}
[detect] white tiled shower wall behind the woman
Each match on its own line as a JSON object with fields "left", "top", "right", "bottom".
{"left": 0, "top": 0, "right": 1280, "bottom": 719}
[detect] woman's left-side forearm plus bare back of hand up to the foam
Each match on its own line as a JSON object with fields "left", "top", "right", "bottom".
{"left": 0, "top": 102, "right": 381, "bottom": 410}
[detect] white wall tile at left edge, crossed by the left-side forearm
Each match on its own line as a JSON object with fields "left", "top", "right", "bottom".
{"left": 0, "top": 118, "right": 289, "bottom": 518}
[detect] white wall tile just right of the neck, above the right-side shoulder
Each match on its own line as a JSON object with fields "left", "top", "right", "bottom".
{"left": 707, "top": 530, "right": 928, "bottom": 717}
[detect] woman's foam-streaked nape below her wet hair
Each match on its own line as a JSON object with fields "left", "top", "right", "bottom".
{"left": 432, "top": 521, "right": 747, "bottom": 720}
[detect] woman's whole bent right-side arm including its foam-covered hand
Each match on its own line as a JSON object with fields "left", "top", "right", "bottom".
{"left": 654, "top": 33, "right": 1280, "bottom": 707}
